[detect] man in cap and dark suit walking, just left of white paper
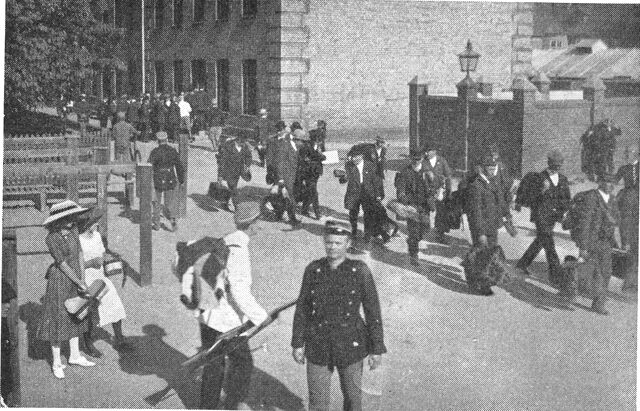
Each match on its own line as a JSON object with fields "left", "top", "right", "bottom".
{"left": 275, "top": 129, "right": 304, "bottom": 226}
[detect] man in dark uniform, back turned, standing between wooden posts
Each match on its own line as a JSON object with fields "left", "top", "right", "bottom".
{"left": 149, "top": 131, "right": 184, "bottom": 232}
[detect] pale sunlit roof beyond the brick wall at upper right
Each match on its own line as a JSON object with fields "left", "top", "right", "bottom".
{"left": 533, "top": 43, "right": 640, "bottom": 80}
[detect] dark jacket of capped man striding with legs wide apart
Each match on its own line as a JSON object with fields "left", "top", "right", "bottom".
{"left": 531, "top": 170, "right": 571, "bottom": 229}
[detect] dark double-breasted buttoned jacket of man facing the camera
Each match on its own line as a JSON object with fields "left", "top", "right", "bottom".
{"left": 291, "top": 258, "right": 387, "bottom": 367}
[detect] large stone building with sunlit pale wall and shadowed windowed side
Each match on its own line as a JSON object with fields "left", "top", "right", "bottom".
{"left": 96, "top": 0, "right": 534, "bottom": 136}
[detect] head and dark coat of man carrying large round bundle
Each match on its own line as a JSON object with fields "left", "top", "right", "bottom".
{"left": 467, "top": 154, "right": 508, "bottom": 247}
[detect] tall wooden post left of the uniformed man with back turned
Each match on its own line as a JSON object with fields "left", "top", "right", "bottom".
{"left": 136, "top": 163, "right": 153, "bottom": 286}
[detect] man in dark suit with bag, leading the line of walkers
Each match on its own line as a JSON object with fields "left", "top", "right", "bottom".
{"left": 219, "top": 137, "right": 251, "bottom": 210}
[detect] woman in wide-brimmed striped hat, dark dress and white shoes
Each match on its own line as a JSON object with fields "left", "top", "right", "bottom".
{"left": 37, "top": 200, "right": 95, "bottom": 378}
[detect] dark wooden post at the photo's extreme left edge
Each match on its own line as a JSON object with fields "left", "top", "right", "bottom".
{"left": 2, "top": 230, "right": 20, "bottom": 407}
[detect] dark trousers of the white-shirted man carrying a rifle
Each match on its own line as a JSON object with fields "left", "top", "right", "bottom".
{"left": 200, "top": 324, "right": 253, "bottom": 410}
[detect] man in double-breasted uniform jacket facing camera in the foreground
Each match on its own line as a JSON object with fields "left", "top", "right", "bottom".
{"left": 291, "top": 221, "right": 387, "bottom": 410}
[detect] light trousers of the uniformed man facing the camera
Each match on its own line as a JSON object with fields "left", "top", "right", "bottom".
{"left": 307, "top": 360, "right": 362, "bottom": 411}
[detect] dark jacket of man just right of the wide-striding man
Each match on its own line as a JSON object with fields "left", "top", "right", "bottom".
{"left": 576, "top": 189, "right": 617, "bottom": 251}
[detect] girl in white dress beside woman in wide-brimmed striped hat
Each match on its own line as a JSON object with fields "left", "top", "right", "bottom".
{"left": 79, "top": 213, "right": 128, "bottom": 356}
